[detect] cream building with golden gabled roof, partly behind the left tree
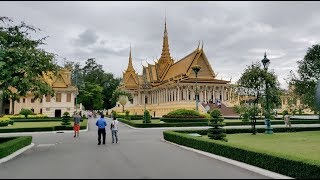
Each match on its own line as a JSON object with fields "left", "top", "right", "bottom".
{"left": 1, "top": 69, "right": 78, "bottom": 117}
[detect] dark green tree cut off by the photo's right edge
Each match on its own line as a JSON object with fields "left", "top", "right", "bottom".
{"left": 290, "top": 44, "right": 320, "bottom": 118}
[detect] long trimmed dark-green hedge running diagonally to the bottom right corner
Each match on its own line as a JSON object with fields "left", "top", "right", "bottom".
{"left": 163, "top": 131, "right": 320, "bottom": 179}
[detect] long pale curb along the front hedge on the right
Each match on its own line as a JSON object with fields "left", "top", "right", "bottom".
{"left": 161, "top": 138, "right": 294, "bottom": 179}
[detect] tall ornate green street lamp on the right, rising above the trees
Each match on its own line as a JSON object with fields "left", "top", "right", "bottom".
{"left": 261, "top": 52, "right": 273, "bottom": 134}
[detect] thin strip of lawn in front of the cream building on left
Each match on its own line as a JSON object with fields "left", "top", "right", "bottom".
{"left": 0, "top": 119, "right": 88, "bottom": 129}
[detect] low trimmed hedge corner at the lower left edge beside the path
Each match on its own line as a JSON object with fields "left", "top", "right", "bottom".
{"left": 0, "top": 136, "right": 32, "bottom": 158}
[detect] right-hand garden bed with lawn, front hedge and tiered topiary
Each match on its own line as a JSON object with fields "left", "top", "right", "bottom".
{"left": 163, "top": 107, "right": 320, "bottom": 179}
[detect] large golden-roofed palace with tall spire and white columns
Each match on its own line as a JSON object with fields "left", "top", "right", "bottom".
{"left": 111, "top": 19, "right": 239, "bottom": 117}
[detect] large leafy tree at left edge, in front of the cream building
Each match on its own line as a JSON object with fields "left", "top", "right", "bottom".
{"left": 0, "top": 17, "right": 58, "bottom": 111}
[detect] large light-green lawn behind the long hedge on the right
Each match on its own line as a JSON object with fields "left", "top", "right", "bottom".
{"left": 202, "top": 131, "right": 320, "bottom": 164}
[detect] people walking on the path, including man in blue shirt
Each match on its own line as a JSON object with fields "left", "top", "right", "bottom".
{"left": 73, "top": 112, "right": 119, "bottom": 145}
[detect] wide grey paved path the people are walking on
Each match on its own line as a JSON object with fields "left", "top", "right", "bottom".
{"left": 0, "top": 119, "right": 274, "bottom": 179}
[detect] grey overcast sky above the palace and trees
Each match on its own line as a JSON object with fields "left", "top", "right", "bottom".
{"left": 0, "top": 1, "right": 320, "bottom": 88}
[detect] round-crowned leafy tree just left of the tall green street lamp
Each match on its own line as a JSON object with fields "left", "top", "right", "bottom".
{"left": 237, "top": 63, "right": 281, "bottom": 134}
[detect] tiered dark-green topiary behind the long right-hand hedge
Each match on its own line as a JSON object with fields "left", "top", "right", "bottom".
{"left": 208, "top": 109, "right": 228, "bottom": 141}
